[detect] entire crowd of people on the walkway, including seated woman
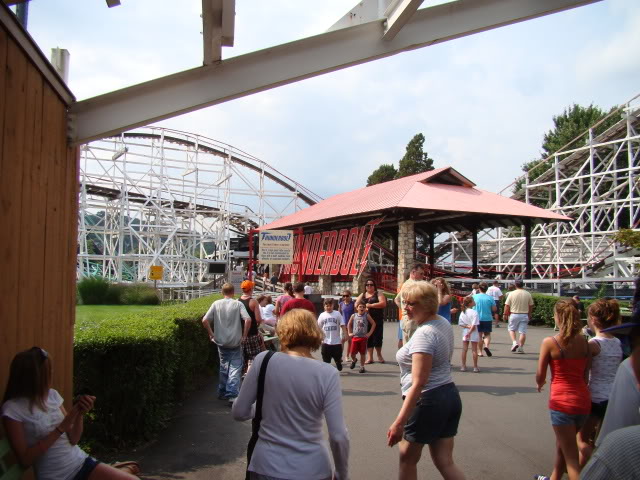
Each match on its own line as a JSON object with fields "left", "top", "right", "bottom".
{"left": 1, "top": 270, "right": 640, "bottom": 480}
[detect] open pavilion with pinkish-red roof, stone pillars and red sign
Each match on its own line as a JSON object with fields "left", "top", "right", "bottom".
{"left": 260, "top": 167, "right": 571, "bottom": 291}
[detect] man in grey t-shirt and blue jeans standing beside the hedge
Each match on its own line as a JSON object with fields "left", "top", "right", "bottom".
{"left": 202, "top": 283, "right": 251, "bottom": 405}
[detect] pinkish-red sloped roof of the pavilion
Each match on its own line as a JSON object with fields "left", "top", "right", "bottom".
{"left": 261, "top": 167, "right": 571, "bottom": 232}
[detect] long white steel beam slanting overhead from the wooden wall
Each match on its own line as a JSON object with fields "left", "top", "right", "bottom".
{"left": 70, "top": 0, "right": 601, "bottom": 144}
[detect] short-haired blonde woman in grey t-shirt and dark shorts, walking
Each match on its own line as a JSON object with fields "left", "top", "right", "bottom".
{"left": 387, "top": 282, "right": 465, "bottom": 480}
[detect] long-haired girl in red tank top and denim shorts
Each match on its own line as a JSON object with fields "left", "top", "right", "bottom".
{"left": 536, "top": 299, "right": 591, "bottom": 480}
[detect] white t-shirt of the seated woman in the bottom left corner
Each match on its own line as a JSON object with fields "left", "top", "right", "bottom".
{"left": 2, "top": 388, "right": 87, "bottom": 480}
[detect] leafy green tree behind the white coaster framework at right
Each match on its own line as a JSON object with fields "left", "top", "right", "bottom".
{"left": 513, "top": 103, "right": 621, "bottom": 192}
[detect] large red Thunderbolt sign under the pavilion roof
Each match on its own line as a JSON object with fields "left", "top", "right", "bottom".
{"left": 284, "top": 218, "right": 382, "bottom": 275}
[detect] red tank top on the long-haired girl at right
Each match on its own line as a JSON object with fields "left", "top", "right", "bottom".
{"left": 549, "top": 338, "right": 591, "bottom": 415}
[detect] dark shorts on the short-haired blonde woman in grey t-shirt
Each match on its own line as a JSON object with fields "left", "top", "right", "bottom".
{"left": 404, "top": 382, "right": 462, "bottom": 444}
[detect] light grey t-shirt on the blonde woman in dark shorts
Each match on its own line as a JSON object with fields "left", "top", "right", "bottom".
{"left": 396, "top": 315, "right": 453, "bottom": 395}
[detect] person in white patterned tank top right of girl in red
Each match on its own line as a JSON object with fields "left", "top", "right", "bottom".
{"left": 574, "top": 297, "right": 622, "bottom": 465}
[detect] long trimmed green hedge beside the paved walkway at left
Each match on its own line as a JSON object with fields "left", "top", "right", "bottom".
{"left": 74, "top": 296, "right": 218, "bottom": 446}
